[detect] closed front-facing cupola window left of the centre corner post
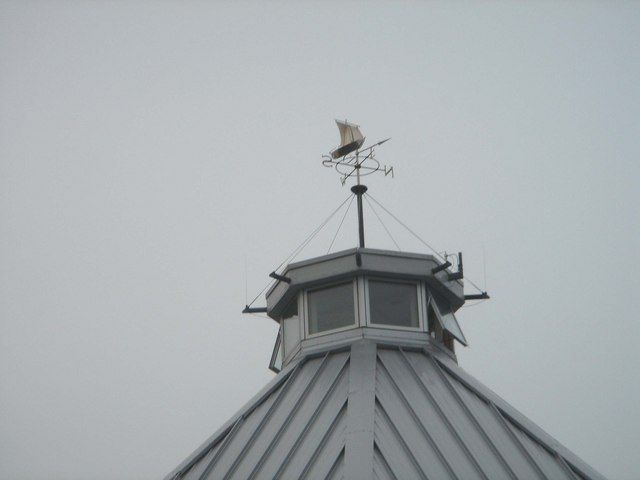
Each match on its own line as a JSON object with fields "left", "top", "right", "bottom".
{"left": 307, "top": 282, "right": 356, "bottom": 334}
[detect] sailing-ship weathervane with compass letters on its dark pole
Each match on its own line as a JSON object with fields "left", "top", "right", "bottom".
{"left": 322, "top": 120, "right": 393, "bottom": 248}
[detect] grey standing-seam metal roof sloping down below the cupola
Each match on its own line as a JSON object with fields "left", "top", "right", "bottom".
{"left": 167, "top": 340, "right": 604, "bottom": 480}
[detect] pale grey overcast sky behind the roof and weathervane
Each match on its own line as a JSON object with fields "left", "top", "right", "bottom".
{"left": 0, "top": 0, "right": 640, "bottom": 480}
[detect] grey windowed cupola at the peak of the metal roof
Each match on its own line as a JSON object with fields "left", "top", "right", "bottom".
{"left": 266, "top": 248, "right": 467, "bottom": 371}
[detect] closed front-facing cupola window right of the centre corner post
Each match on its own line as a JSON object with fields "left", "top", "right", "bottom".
{"left": 369, "top": 280, "right": 418, "bottom": 328}
